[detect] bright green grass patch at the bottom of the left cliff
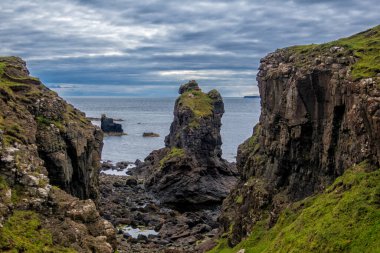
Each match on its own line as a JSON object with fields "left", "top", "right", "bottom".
{"left": 0, "top": 211, "right": 76, "bottom": 253}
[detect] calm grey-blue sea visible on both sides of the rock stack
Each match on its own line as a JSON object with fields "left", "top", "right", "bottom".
{"left": 65, "top": 97, "right": 260, "bottom": 162}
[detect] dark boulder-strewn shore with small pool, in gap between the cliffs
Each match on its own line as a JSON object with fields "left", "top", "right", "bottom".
{"left": 99, "top": 174, "right": 220, "bottom": 252}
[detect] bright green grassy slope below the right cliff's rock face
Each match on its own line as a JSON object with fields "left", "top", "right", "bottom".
{"left": 210, "top": 163, "right": 380, "bottom": 253}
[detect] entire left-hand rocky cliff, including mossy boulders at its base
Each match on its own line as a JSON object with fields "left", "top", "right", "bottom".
{"left": 0, "top": 57, "right": 114, "bottom": 252}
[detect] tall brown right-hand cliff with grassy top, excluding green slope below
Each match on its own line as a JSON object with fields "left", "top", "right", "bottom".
{"left": 221, "top": 27, "right": 380, "bottom": 245}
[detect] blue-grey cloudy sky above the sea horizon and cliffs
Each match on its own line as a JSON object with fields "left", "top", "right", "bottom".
{"left": 0, "top": 0, "right": 380, "bottom": 97}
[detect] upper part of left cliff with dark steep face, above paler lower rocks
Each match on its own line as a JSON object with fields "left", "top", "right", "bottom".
{"left": 0, "top": 58, "right": 103, "bottom": 199}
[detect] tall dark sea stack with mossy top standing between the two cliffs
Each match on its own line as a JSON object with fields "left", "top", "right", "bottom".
{"left": 138, "top": 81, "right": 236, "bottom": 208}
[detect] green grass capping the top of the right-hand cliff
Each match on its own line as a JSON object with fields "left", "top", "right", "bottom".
{"left": 287, "top": 25, "right": 380, "bottom": 79}
